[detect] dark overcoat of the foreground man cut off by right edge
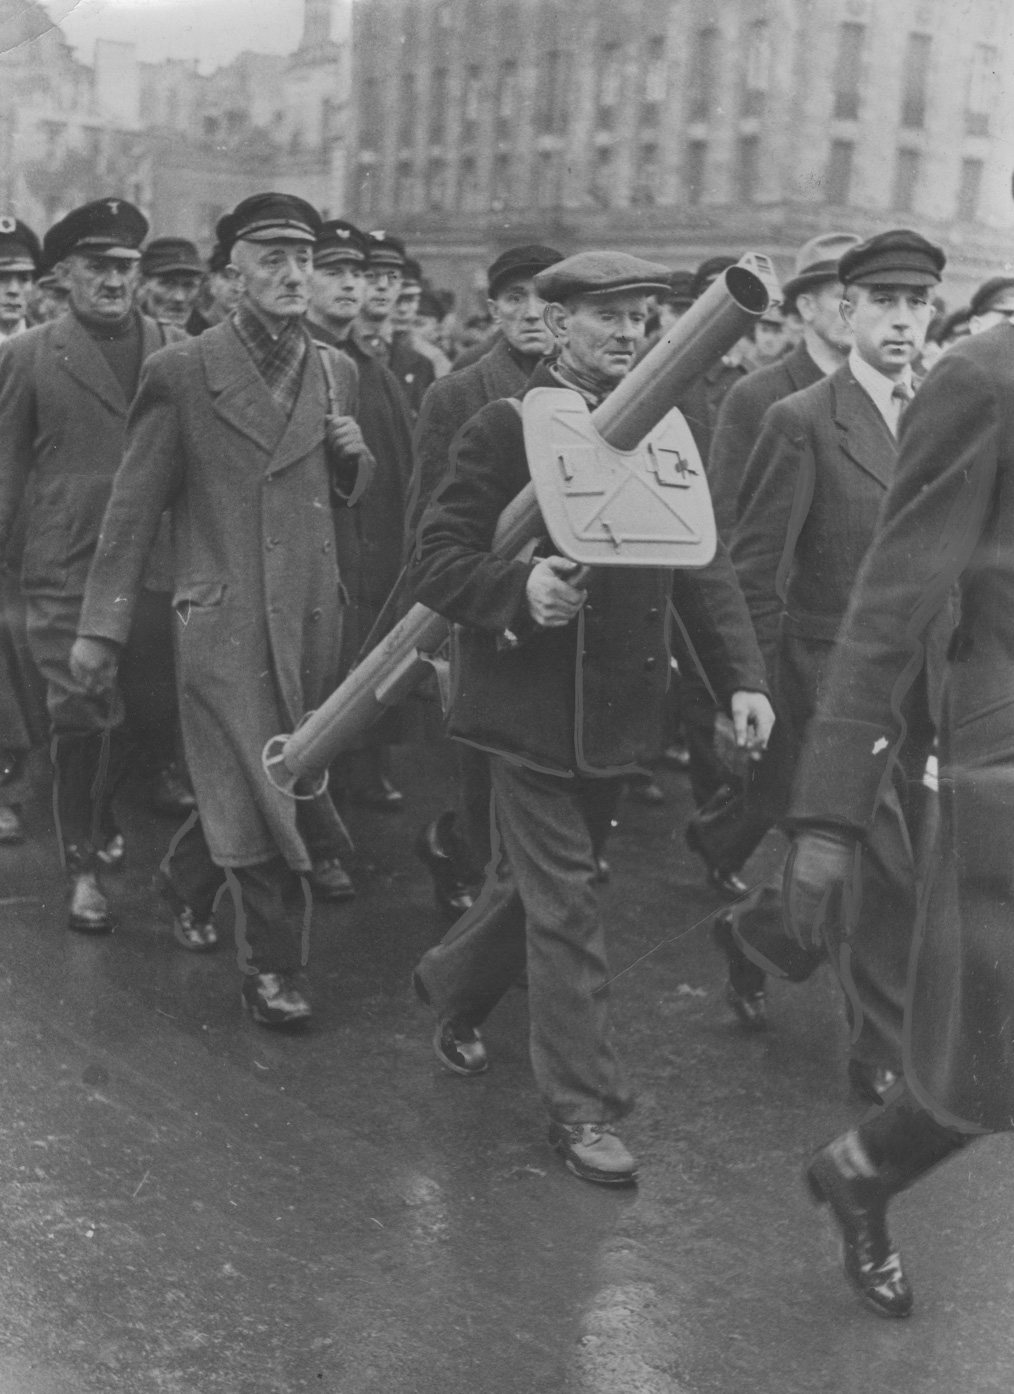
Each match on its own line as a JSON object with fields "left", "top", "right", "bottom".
{"left": 792, "top": 325, "right": 1014, "bottom": 1129}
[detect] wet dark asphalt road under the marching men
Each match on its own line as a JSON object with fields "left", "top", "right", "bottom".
{"left": 0, "top": 749, "right": 1014, "bottom": 1394}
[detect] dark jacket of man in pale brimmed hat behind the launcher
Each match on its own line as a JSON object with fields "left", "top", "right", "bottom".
{"left": 707, "top": 343, "right": 824, "bottom": 542}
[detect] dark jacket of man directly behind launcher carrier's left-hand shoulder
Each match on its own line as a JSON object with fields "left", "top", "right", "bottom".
{"left": 404, "top": 339, "right": 529, "bottom": 551}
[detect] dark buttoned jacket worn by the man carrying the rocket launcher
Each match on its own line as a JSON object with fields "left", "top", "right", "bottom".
{"left": 414, "top": 367, "right": 764, "bottom": 775}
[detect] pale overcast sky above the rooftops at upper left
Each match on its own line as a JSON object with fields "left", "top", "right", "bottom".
{"left": 42, "top": 0, "right": 303, "bottom": 70}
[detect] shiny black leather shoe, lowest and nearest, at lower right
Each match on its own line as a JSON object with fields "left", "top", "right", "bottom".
{"left": 805, "top": 1133, "right": 912, "bottom": 1316}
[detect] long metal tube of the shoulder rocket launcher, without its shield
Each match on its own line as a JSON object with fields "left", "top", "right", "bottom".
{"left": 264, "top": 256, "right": 771, "bottom": 790}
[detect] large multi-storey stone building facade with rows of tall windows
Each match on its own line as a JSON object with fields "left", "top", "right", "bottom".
{"left": 349, "top": 0, "right": 1014, "bottom": 302}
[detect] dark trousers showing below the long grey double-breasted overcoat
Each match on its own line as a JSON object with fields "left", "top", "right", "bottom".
{"left": 162, "top": 813, "right": 312, "bottom": 973}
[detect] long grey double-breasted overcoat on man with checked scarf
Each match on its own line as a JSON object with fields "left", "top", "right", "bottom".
{"left": 80, "top": 322, "right": 367, "bottom": 871}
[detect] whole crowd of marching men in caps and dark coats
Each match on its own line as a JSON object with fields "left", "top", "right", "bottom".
{"left": 0, "top": 194, "right": 1014, "bottom": 1316}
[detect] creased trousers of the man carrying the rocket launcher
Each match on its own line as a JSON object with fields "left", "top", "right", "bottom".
{"left": 418, "top": 756, "right": 632, "bottom": 1124}
